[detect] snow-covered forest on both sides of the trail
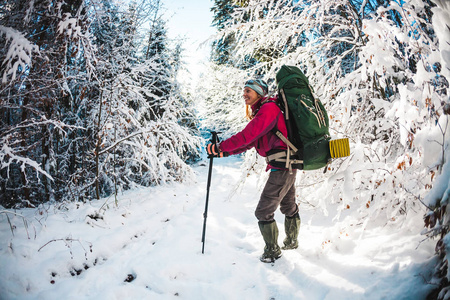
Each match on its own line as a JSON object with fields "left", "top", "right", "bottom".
{"left": 0, "top": 0, "right": 450, "bottom": 299}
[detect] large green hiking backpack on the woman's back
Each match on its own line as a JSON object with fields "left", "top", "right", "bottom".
{"left": 267, "top": 65, "right": 331, "bottom": 170}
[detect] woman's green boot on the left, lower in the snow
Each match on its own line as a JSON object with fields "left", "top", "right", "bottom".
{"left": 258, "top": 220, "right": 281, "bottom": 263}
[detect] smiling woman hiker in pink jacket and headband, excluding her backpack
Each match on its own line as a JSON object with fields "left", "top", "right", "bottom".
{"left": 207, "top": 79, "right": 300, "bottom": 262}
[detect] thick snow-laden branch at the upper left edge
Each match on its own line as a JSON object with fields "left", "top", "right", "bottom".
{"left": 0, "top": 25, "right": 39, "bottom": 84}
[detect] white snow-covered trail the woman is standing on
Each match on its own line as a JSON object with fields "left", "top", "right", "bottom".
{"left": 0, "top": 158, "right": 434, "bottom": 300}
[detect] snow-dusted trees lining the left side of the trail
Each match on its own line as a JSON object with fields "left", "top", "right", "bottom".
{"left": 0, "top": 0, "right": 199, "bottom": 206}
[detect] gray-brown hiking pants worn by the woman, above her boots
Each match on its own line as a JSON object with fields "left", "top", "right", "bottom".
{"left": 255, "top": 170, "right": 298, "bottom": 222}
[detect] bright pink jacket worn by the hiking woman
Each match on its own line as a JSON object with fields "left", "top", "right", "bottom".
{"left": 219, "top": 98, "right": 287, "bottom": 168}
